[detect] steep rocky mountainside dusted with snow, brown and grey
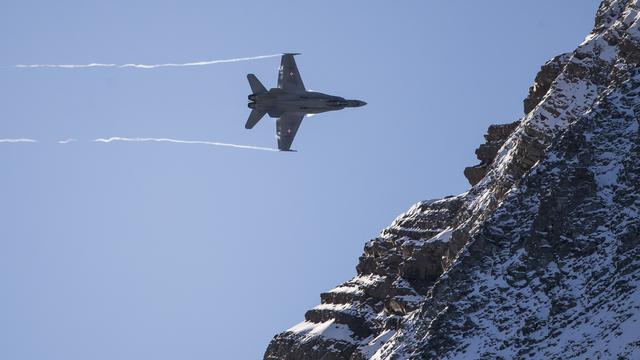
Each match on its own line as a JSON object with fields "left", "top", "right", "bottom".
{"left": 265, "top": 0, "right": 640, "bottom": 359}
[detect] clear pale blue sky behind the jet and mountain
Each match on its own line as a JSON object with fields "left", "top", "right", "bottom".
{"left": 0, "top": 0, "right": 599, "bottom": 360}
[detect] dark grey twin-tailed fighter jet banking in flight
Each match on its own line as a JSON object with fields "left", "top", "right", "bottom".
{"left": 244, "top": 53, "right": 367, "bottom": 151}
